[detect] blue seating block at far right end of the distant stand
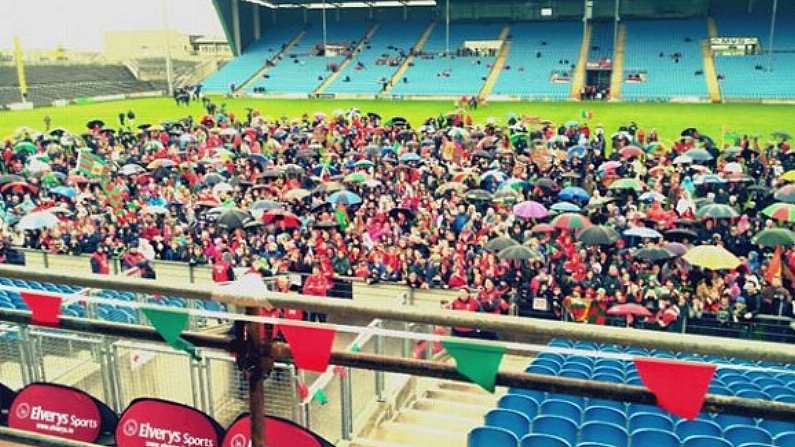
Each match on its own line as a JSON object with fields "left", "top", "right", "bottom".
{"left": 715, "top": 11, "right": 795, "bottom": 99}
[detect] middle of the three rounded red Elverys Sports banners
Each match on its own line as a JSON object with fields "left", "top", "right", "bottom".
{"left": 116, "top": 399, "right": 223, "bottom": 447}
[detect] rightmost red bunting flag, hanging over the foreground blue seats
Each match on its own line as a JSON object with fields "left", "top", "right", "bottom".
{"left": 634, "top": 358, "right": 715, "bottom": 419}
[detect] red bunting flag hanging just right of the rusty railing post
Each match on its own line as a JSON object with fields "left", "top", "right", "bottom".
{"left": 279, "top": 324, "right": 337, "bottom": 373}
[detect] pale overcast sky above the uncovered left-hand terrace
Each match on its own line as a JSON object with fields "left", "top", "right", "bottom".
{"left": 0, "top": 0, "right": 223, "bottom": 50}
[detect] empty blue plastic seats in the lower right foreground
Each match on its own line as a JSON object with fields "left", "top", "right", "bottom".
{"left": 468, "top": 340, "right": 795, "bottom": 447}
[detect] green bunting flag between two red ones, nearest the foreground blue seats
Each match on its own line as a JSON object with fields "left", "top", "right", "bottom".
{"left": 442, "top": 341, "right": 505, "bottom": 393}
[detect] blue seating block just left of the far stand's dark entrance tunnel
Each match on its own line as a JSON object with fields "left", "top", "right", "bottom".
{"left": 492, "top": 22, "right": 582, "bottom": 99}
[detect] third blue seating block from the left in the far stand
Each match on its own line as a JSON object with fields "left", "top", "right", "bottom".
{"left": 327, "top": 21, "right": 428, "bottom": 94}
